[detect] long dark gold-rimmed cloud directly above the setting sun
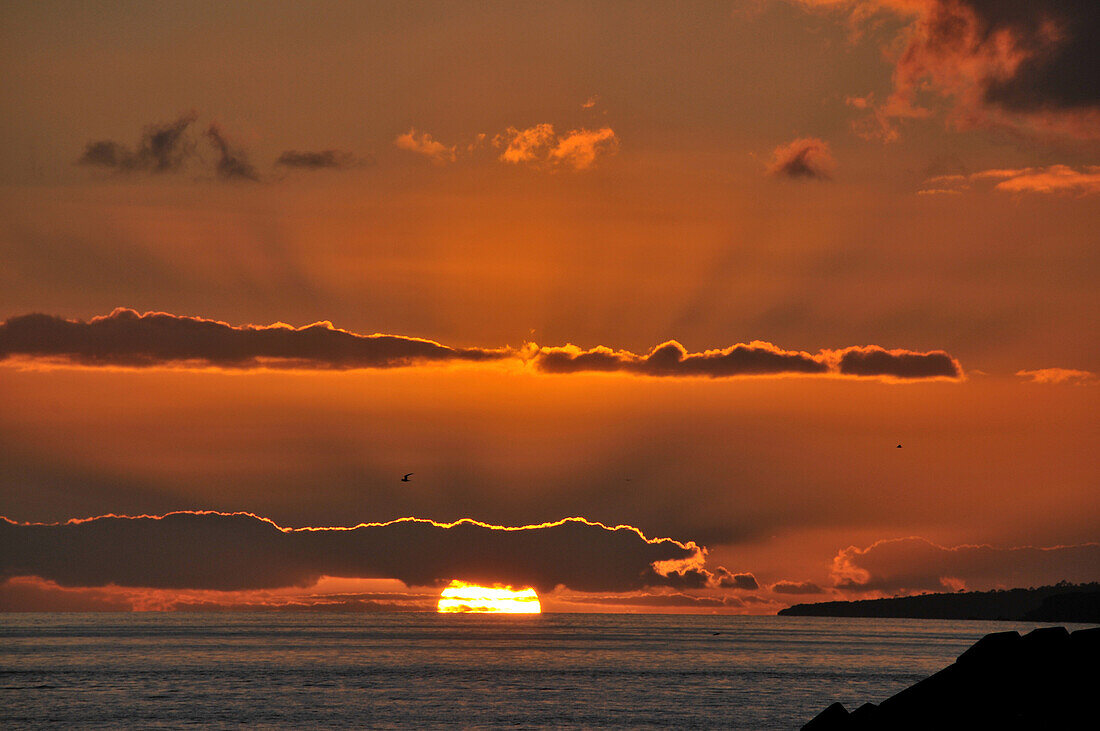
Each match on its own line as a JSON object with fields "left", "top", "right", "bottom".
{"left": 0, "top": 511, "right": 705, "bottom": 591}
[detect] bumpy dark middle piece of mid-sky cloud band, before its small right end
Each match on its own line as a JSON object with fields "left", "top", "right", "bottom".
{"left": 535, "top": 341, "right": 828, "bottom": 378}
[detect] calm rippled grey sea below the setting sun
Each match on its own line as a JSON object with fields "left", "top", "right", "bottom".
{"left": 0, "top": 613, "right": 1086, "bottom": 729}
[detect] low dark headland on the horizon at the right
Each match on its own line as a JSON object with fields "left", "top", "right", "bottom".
{"left": 778, "top": 582, "right": 1100, "bottom": 623}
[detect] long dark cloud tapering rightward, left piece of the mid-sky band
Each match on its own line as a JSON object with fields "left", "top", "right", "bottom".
{"left": 0, "top": 308, "right": 508, "bottom": 369}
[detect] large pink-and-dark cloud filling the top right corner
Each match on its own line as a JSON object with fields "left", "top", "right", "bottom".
{"left": 801, "top": 0, "right": 1100, "bottom": 140}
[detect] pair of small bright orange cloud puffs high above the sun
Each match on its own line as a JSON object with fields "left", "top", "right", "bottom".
{"left": 493, "top": 124, "right": 618, "bottom": 170}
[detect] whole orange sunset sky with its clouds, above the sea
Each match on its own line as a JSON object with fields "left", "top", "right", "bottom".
{"left": 0, "top": 0, "right": 1100, "bottom": 613}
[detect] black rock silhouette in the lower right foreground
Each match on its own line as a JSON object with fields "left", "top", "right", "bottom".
{"left": 802, "top": 627, "right": 1100, "bottom": 731}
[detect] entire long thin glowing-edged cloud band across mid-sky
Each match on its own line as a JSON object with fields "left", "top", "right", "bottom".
{"left": 0, "top": 308, "right": 963, "bottom": 379}
